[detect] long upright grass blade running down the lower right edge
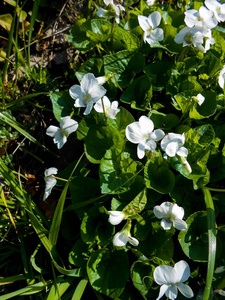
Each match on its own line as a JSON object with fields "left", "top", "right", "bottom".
{"left": 202, "top": 189, "right": 216, "bottom": 300}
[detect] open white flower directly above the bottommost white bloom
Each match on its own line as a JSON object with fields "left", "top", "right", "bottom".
{"left": 153, "top": 202, "right": 187, "bottom": 230}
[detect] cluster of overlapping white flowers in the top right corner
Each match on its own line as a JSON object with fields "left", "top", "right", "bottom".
{"left": 175, "top": 0, "right": 225, "bottom": 53}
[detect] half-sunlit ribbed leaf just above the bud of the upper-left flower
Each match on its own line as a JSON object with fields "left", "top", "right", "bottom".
{"left": 104, "top": 50, "right": 144, "bottom": 88}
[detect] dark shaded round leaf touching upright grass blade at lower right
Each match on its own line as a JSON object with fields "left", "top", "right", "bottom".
{"left": 178, "top": 211, "right": 208, "bottom": 262}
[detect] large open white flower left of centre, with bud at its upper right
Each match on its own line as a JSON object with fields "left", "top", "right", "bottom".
{"left": 69, "top": 73, "right": 106, "bottom": 115}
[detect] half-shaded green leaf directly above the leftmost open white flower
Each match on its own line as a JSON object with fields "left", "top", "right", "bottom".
{"left": 50, "top": 91, "right": 74, "bottom": 122}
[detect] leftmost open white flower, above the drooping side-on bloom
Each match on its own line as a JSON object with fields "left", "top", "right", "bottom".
{"left": 46, "top": 116, "right": 78, "bottom": 149}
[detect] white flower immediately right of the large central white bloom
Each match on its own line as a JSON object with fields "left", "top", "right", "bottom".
{"left": 161, "top": 133, "right": 188, "bottom": 157}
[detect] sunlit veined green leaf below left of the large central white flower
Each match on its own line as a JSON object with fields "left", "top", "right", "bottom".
{"left": 99, "top": 147, "right": 137, "bottom": 194}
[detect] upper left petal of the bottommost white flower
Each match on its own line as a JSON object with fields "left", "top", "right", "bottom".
{"left": 153, "top": 265, "right": 177, "bottom": 285}
